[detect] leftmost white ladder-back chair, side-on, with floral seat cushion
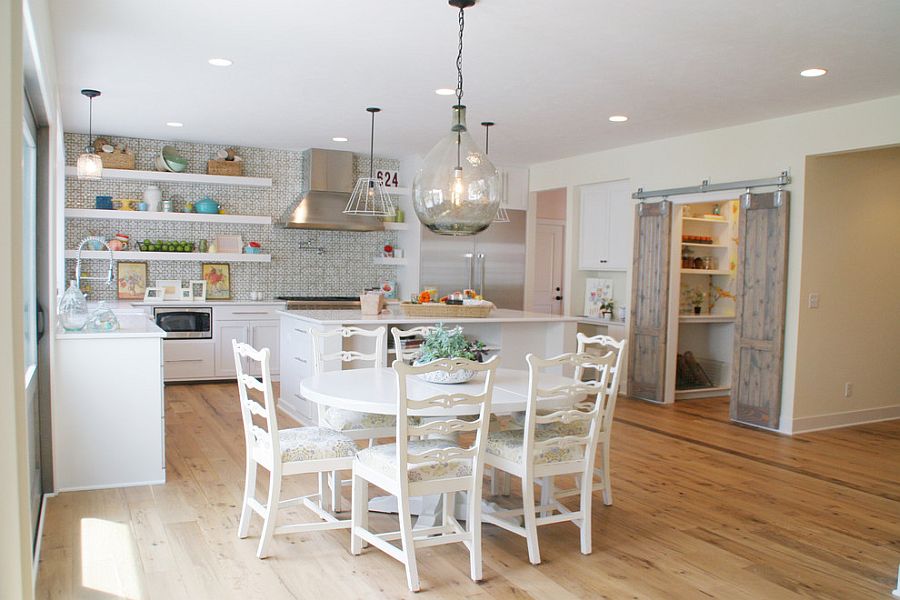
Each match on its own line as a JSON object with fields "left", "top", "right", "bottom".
{"left": 231, "top": 340, "right": 357, "bottom": 558}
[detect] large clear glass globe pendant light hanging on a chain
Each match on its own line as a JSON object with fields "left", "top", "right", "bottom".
{"left": 413, "top": 0, "right": 500, "bottom": 235}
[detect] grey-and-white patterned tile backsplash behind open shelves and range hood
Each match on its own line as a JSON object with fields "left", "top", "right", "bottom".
{"left": 65, "top": 133, "right": 399, "bottom": 300}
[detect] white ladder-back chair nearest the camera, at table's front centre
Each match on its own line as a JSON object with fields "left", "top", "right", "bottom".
{"left": 350, "top": 357, "right": 499, "bottom": 591}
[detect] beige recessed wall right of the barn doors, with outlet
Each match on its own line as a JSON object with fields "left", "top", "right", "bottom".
{"left": 794, "top": 147, "right": 900, "bottom": 429}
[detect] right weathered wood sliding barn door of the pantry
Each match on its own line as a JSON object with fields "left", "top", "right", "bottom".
{"left": 731, "top": 190, "right": 790, "bottom": 429}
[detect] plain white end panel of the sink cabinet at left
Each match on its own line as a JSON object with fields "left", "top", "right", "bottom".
{"left": 52, "top": 333, "right": 166, "bottom": 492}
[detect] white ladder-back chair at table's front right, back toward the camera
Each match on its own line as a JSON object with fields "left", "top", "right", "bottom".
{"left": 482, "top": 352, "right": 615, "bottom": 565}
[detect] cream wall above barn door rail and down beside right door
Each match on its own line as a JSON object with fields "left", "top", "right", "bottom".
{"left": 530, "top": 96, "right": 900, "bottom": 433}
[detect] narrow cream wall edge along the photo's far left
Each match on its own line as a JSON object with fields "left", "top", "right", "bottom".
{"left": 0, "top": 0, "right": 32, "bottom": 598}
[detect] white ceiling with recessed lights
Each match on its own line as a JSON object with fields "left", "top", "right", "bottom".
{"left": 51, "top": 0, "right": 900, "bottom": 165}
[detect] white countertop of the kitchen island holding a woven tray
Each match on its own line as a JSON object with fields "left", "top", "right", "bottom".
{"left": 278, "top": 308, "right": 579, "bottom": 325}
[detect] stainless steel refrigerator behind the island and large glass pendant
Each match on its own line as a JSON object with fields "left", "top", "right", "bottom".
{"left": 419, "top": 210, "right": 525, "bottom": 310}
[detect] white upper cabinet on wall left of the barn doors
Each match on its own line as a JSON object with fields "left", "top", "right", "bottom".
{"left": 578, "top": 181, "right": 634, "bottom": 271}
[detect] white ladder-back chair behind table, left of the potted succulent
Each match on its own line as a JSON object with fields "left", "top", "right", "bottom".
{"left": 311, "top": 327, "right": 396, "bottom": 511}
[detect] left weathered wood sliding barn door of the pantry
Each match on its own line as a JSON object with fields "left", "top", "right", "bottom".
{"left": 628, "top": 200, "right": 672, "bottom": 402}
